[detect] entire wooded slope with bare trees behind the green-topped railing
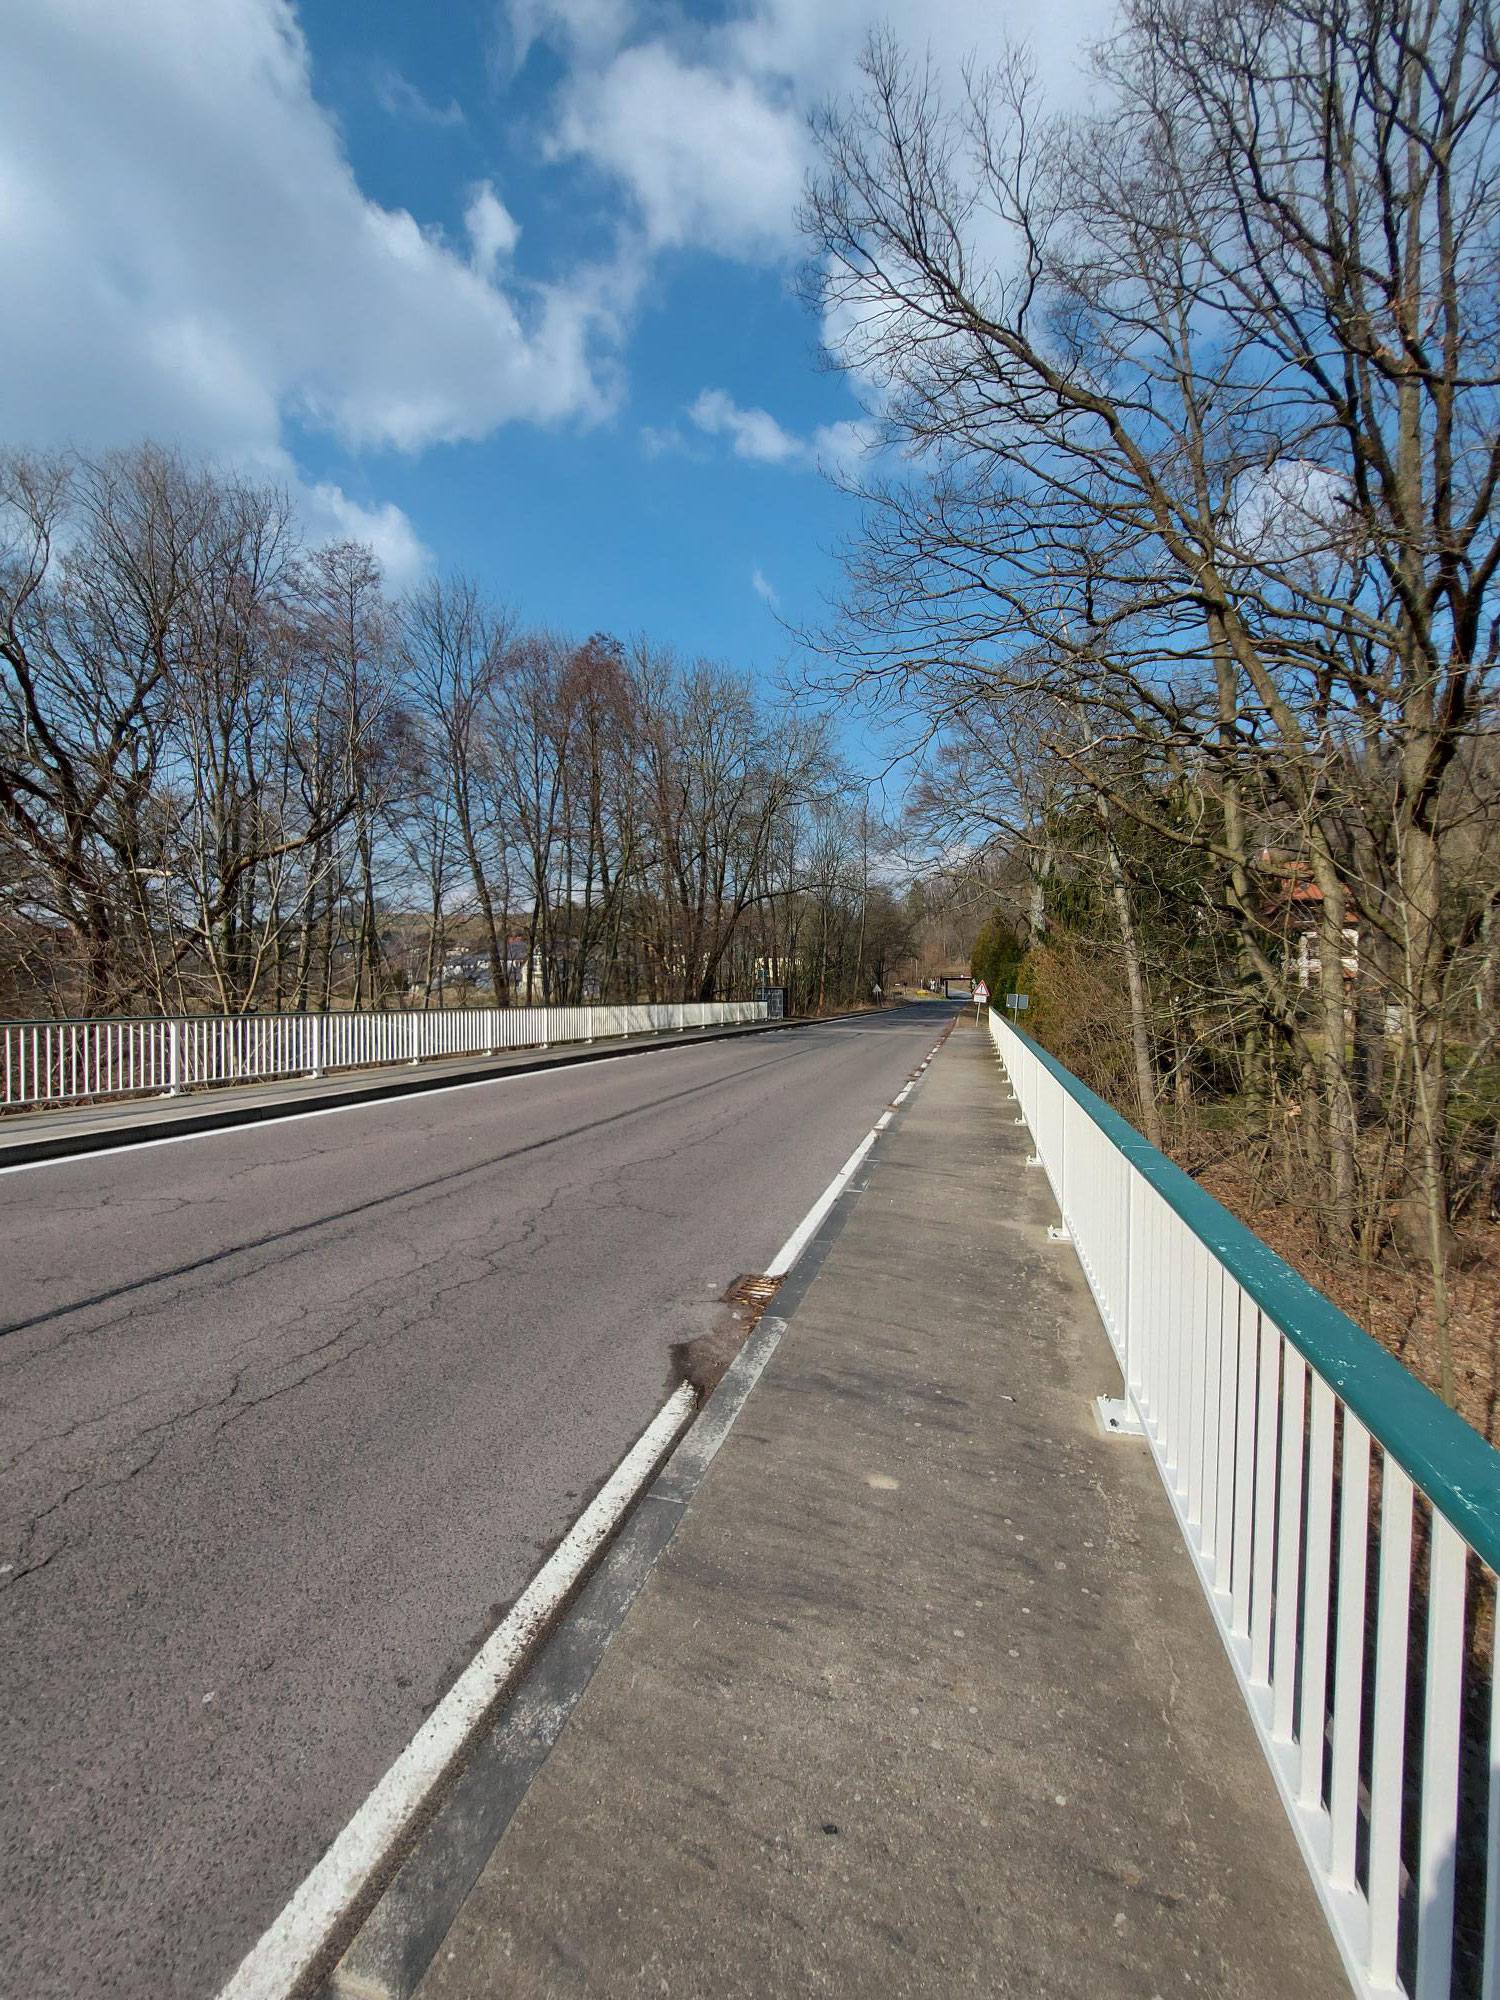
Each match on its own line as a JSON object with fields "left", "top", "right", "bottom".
{"left": 804, "top": 0, "right": 1500, "bottom": 1432}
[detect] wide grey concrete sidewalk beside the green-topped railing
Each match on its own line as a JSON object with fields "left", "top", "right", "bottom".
{"left": 420, "top": 1022, "right": 1348, "bottom": 2000}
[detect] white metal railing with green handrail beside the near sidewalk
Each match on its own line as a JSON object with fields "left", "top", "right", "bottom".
{"left": 990, "top": 1014, "right": 1500, "bottom": 2000}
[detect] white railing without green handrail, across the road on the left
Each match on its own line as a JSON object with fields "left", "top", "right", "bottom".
{"left": 0, "top": 996, "right": 780, "bottom": 1108}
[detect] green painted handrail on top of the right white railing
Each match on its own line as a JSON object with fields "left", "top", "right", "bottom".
{"left": 1006, "top": 1022, "right": 1500, "bottom": 1570}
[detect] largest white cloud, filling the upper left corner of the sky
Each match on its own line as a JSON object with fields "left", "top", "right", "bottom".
{"left": 0, "top": 0, "right": 626, "bottom": 476}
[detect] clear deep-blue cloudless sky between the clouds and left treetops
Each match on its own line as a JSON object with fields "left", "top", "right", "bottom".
{"left": 298, "top": 0, "right": 876, "bottom": 670}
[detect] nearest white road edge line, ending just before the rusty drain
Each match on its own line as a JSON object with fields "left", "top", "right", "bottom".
{"left": 218, "top": 1384, "right": 696, "bottom": 2000}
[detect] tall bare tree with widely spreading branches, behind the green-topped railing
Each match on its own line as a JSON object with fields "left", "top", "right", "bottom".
{"left": 806, "top": 0, "right": 1500, "bottom": 1388}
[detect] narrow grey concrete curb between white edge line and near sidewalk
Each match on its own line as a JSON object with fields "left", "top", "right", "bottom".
{"left": 312, "top": 1016, "right": 946, "bottom": 2000}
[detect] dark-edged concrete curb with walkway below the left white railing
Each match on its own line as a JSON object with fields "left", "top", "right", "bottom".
{"left": 0, "top": 1014, "right": 864, "bottom": 1172}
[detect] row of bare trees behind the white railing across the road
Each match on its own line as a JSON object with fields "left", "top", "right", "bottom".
{"left": 0, "top": 446, "right": 916, "bottom": 1016}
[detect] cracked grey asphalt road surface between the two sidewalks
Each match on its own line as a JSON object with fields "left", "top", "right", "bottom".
{"left": 0, "top": 1006, "right": 948, "bottom": 2000}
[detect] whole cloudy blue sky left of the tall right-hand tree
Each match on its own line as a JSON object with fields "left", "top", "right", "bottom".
{"left": 0, "top": 0, "right": 1102, "bottom": 772}
